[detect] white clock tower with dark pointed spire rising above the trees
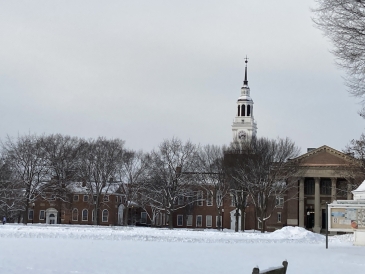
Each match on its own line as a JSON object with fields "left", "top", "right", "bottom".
{"left": 232, "top": 57, "right": 257, "bottom": 141}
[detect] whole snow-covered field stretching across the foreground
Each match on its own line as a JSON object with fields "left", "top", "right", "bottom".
{"left": 0, "top": 224, "right": 365, "bottom": 274}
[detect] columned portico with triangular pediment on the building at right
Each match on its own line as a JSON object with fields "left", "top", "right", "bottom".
{"left": 288, "top": 146, "right": 362, "bottom": 233}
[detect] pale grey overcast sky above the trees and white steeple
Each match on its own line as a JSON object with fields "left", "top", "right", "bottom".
{"left": 0, "top": 0, "right": 365, "bottom": 152}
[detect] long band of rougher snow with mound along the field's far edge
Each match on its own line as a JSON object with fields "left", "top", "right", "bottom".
{"left": 0, "top": 224, "right": 346, "bottom": 243}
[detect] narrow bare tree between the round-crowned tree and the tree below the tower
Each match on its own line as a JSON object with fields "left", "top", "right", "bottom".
{"left": 198, "top": 145, "right": 230, "bottom": 230}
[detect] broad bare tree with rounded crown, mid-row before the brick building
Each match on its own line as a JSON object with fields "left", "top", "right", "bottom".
{"left": 144, "top": 138, "right": 198, "bottom": 229}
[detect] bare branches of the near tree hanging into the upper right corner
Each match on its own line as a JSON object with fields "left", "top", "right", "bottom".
{"left": 313, "top": 0, "right": 365, "bottom": 117}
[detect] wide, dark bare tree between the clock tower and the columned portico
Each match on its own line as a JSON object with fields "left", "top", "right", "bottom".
{"left": 229, "top": 138, "right": 300, "bottom": 232}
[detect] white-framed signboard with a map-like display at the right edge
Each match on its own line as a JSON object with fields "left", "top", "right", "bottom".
{"left": 328, "top": 204, "right": 365, "bottom": 232}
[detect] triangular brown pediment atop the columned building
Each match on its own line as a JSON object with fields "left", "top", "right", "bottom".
{"left": 293, "top": 146, "right": 355, "bottom": 167}
